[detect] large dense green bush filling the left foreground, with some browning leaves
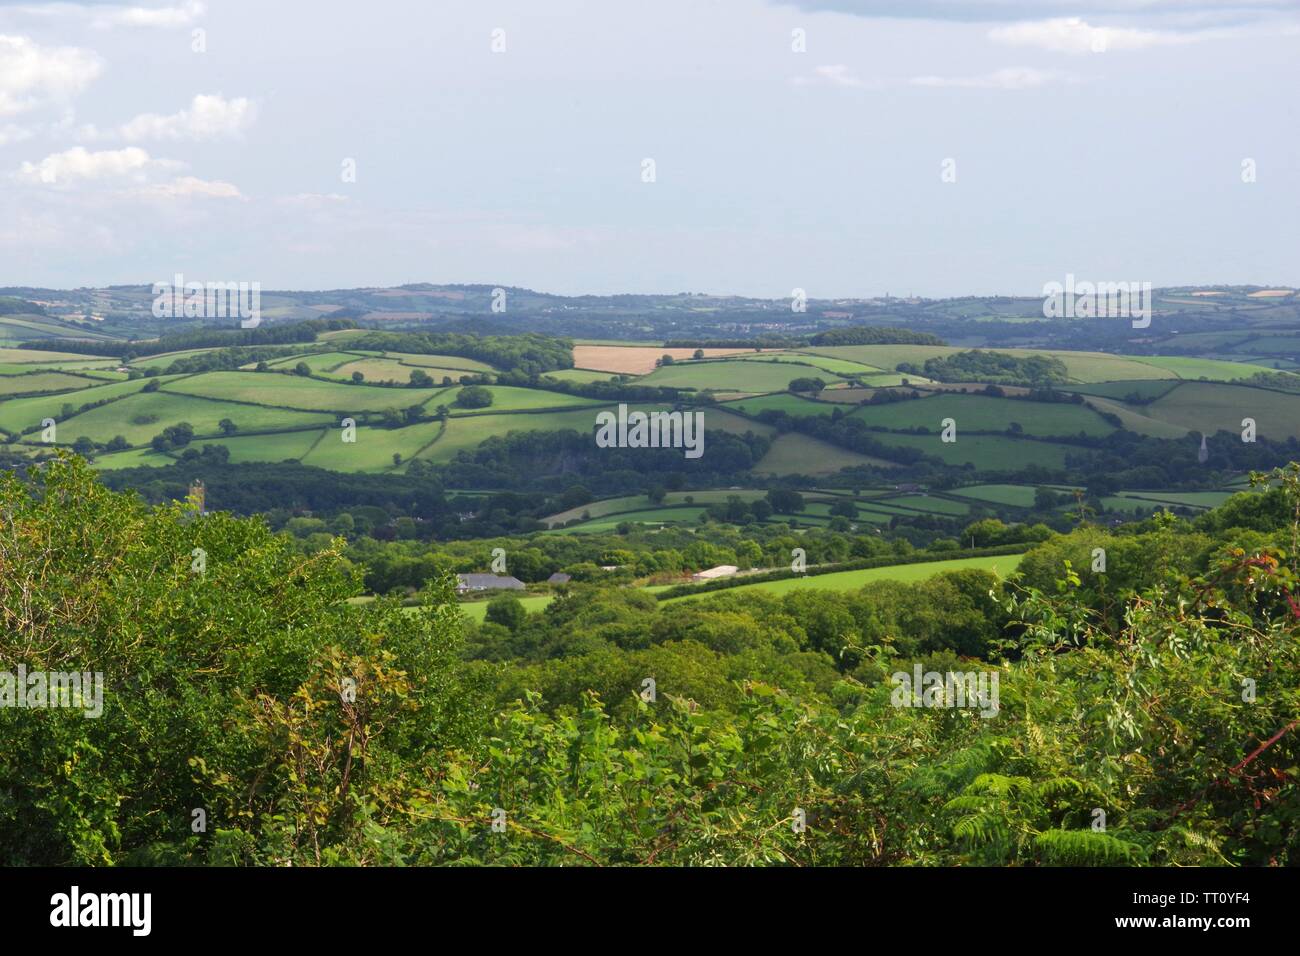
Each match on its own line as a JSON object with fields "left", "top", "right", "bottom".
{"left": 0, "top": 455, "right": 488, "bottom": 866}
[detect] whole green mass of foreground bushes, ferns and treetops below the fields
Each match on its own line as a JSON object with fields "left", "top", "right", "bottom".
{"left": 0, "top": 457, "right": 1300, "bottom": 865}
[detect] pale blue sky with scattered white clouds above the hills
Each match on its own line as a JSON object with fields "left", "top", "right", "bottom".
{"left": 0, "top": 0, "right": 1300, "bottom": 298}
